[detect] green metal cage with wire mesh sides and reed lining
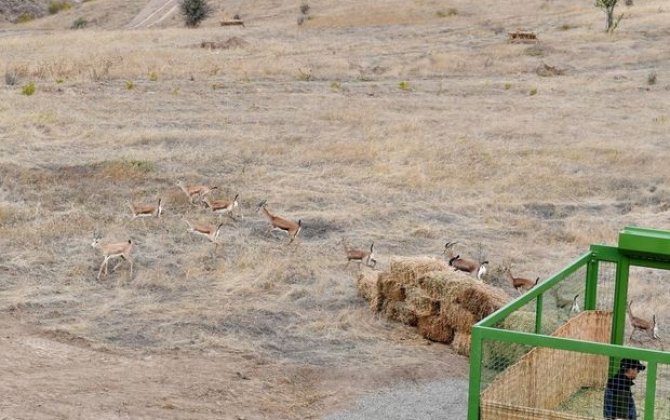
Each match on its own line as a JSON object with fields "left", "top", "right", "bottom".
{"left": 468, "top": 227, "right": 670, "bottom": 420}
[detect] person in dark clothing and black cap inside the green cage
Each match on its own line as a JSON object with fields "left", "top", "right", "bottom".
{"left": 603, "top": 359, "right": 646, "bottom": 420}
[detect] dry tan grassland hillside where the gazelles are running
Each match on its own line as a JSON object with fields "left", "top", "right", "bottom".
{"left": 0, "top": 0, "right": 670, "bottom": 419}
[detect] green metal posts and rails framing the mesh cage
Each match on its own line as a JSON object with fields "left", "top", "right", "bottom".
{"left": 468, "top": 227, "right": 670, "bottom": 420}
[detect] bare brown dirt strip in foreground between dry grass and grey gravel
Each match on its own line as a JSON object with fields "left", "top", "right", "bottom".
{"left": 0, "top": 315, "right": 467, "bottom": 420}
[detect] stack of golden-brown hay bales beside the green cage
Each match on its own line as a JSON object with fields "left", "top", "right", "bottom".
{"left": 358, "top": 257, "right": 510, "bottom": 354}
